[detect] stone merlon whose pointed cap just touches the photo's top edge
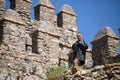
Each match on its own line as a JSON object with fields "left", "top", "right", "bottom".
{"left": 34, "top": 0, "right": 55, "bottom": 24}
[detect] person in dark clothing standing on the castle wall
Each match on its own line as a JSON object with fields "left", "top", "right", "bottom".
{"left": 72, "top": 33, "right": 88, "bottom": 66}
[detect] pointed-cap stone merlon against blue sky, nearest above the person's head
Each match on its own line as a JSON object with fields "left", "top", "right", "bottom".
{"left": 57, "top": 4, "right": 76, "bottom": 29}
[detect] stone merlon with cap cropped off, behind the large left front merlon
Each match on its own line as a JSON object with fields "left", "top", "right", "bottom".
{"left": 10, "top": 0, "right": 31, "bottom": 30}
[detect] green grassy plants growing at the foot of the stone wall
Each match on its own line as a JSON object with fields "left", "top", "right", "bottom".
{"left": 46, "top": 66, "right": 68, "bottom": 80}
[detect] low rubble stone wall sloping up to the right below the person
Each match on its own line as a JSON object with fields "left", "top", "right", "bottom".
{"left": 64, "top": 63, "right": 120, "bottom": 80}
